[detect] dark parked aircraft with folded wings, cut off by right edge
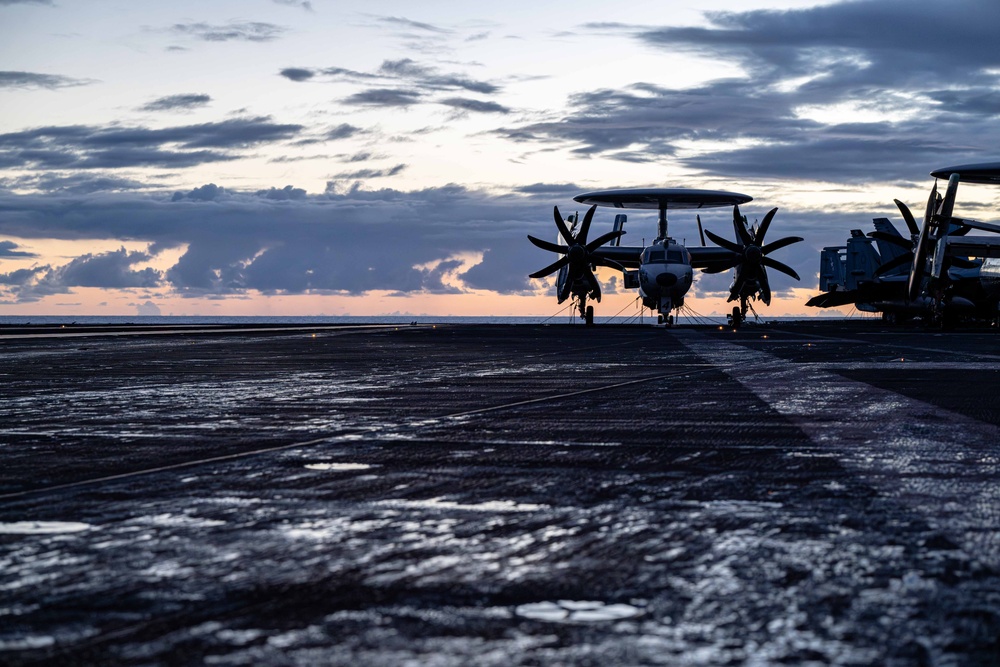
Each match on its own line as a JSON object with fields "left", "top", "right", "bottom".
{"left": 806, "top": 163, "right": 1000, "bottom": 326}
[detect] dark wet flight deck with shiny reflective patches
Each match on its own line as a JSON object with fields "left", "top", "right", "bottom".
{"left": 0, "top": 322, "right": 1000, "bottom": 666}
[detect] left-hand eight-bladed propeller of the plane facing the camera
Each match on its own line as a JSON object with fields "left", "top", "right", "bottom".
{"left": 528, "top": 205, "right": 625, "bottom": 303}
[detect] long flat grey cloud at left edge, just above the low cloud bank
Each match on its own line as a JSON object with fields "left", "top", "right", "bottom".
{"left": 0, "top": 117, "right": 303, "bottom": 174}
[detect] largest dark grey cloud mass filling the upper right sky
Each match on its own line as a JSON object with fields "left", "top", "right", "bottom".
{"left": 497, "top": 0, "right": 1000, "bottom": 183}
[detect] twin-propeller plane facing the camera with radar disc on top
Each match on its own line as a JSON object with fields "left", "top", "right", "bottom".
{"left": 528, "top": 188, "right": 802, "bottom": 328}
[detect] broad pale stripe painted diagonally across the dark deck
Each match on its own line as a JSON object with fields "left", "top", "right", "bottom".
{"left": 675, "top": 331, "right": 1000, "bottom": 565}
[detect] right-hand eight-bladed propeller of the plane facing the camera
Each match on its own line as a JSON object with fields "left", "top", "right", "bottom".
{"left": 703, "top": 206, "right": 802, "bottom": 304}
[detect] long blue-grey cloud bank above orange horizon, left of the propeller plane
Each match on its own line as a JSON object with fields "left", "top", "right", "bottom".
{"left": 0, "top": 184, "right": 564, "bottom": 301}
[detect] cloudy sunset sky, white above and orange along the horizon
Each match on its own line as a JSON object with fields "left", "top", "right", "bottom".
{"left": 0, "top": 0, "right": 1000, "bottom": 316}
